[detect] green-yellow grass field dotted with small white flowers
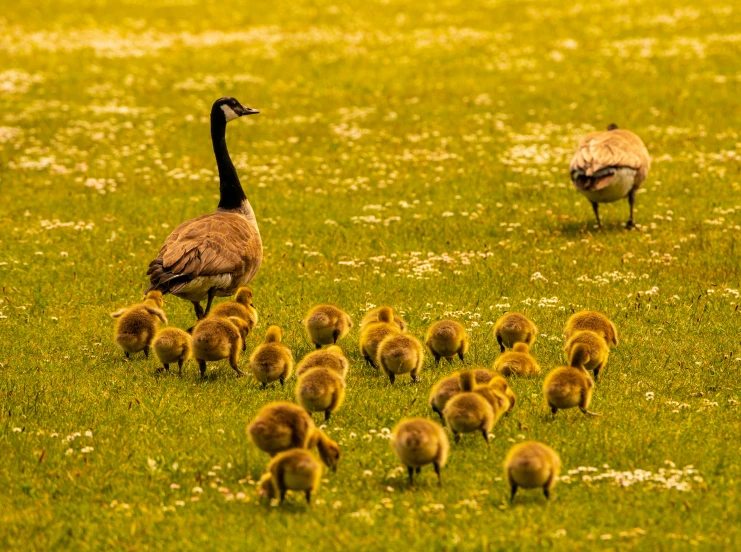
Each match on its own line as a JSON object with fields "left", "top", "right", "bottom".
{"left": 0, "top": 0, "right": 741, "bottom": 551}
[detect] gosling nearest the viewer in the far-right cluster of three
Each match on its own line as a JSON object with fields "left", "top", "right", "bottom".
{"left": 543, "top": 346, "right": 599, "bottom": 416}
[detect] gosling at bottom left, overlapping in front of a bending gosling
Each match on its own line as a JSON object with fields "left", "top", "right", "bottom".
{"left": 257, "top": 449, "right": 322, "bottom": 506}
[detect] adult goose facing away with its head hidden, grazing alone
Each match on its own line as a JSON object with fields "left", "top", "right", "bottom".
{"left": 569, "top": 124, "right": 651, "bottom": 228}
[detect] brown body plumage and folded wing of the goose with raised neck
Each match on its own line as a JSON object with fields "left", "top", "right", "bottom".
{"left": 147, "top": 212, "right": 262, "bottom": 293}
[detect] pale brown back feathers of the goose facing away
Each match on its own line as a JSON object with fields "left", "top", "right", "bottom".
{"left": 570, "top": 129, "right": 651, "bottom": 180}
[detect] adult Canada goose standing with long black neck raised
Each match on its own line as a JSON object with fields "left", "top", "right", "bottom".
{"left": 147, "top": 98, "right": 262, "bottom": 320}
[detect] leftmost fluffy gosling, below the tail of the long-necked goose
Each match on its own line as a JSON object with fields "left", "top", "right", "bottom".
{"left": 111, "top": 291, "right": 167, "bottom": 358}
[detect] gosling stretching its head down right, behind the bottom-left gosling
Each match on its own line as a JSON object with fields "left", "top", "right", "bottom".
{"left": 247, "top": 402, "right": 341, "bottom": 471}
